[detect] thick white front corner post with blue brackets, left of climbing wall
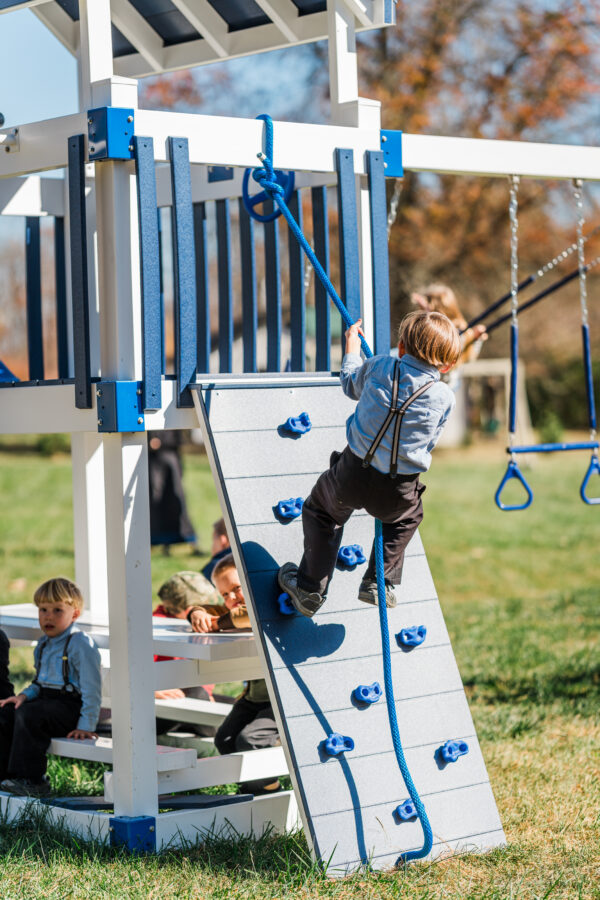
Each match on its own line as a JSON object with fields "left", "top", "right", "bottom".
{"left": 79, "top": 0, "right": 158, "bottom": 816}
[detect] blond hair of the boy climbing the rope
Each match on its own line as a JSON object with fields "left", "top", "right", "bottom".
{"left": 398, "top": 309, "right": 460, "bottom": 367}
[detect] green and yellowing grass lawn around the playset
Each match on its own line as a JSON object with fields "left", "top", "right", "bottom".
{"left": 0, "top": 447, "right": 600, "bottom": 900}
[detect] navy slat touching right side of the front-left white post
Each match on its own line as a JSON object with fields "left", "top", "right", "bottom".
{"left": 133, "top": 136, "right": 162, "bottom": 409}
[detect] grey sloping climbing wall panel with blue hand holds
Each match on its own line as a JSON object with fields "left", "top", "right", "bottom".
{"left": 195, "top": 377, "right": 504, "bottom": 875}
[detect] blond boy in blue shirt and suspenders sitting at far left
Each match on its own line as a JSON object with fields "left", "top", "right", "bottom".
{"left": 0, "top": 578, "right": 102, "bottom": 796}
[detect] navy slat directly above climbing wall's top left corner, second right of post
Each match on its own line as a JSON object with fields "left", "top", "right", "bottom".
{"left": 169, "top": 138, "right": 196, "bottom": 406}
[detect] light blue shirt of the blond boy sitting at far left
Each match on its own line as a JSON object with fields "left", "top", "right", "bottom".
{"left": 21, "top": 624, "right": 102, "bottom": 731}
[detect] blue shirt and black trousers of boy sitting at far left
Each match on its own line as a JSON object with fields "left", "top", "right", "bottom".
{"left": 0, "top": 625, "right": 102, "bottom": 781}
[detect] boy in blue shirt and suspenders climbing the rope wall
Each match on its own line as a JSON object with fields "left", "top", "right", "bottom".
{"left": 279, "top": 310, "right": 460, "bottom": 617}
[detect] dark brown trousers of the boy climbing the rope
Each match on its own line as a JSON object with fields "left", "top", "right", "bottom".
{"left": 298, "top": 447, "right": 425, "bottom": 594}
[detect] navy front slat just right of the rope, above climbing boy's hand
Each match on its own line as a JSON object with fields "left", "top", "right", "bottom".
{"left": 335, "top": 149, "right": 360, "bottom": 343}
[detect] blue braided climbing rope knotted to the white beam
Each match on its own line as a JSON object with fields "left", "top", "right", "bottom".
{"left": 244, "top": 115, "right": 433, "bottom": 863}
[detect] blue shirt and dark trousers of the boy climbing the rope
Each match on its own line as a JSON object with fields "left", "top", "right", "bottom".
{"left": 297, "top": 353, "right": 454, "bottom": 596}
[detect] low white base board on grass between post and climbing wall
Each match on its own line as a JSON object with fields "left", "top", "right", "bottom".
{"left": 156, "top": 791, "right": 298, "bottom": 849}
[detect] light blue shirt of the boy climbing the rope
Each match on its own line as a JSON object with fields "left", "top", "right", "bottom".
{"left": 340, "top": 353, "right": 455, "bottom": 475}
